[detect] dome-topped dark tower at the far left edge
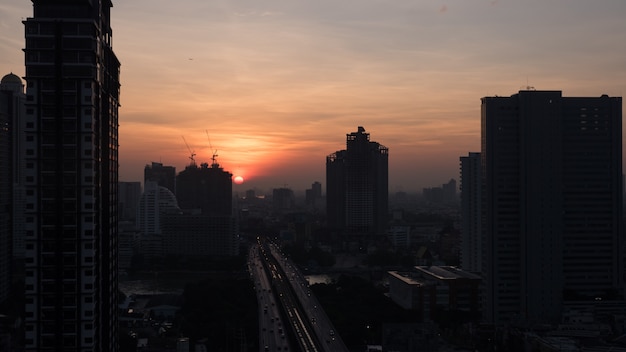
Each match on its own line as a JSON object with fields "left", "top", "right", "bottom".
{"left": 0, "top": 73, "right": 25, "bottom": 302}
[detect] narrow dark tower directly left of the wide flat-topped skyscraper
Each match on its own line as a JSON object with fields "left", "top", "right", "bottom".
{"left": 460, "top": 153, "right": 482, "bottom": 273}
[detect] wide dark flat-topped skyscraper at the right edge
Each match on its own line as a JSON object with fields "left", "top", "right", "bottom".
{"left": 481, "top": 91, "right": 624, "bottom": 323}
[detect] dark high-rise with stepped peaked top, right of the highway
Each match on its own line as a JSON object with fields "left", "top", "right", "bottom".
{"left": 326, "top": 126, "right": 389, "bottom": 237}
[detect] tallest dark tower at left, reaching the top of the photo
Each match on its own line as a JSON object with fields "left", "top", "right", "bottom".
{"left": 21, "top": 0, "right": 120, "bottom": 352}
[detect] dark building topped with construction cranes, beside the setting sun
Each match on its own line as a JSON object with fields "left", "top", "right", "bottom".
{"left": 176, "top": 163, "right": 233, "bottom": 216}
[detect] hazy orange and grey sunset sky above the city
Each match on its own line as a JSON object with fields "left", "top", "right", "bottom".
{"left": 0, "top": 0, "right": 626, "bottom": 192}
